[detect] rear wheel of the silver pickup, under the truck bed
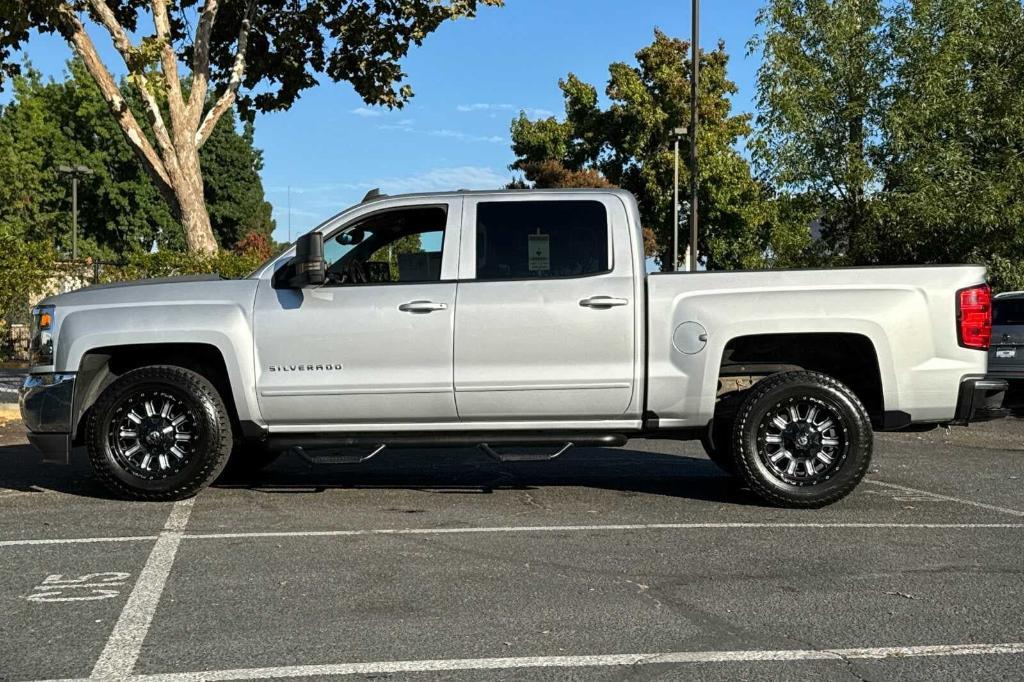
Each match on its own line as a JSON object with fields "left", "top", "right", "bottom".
{"left": 733, "top": 371, "right": 873, "bottom": 508}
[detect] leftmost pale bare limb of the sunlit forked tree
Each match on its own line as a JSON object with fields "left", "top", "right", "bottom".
{"left": 57, "top": 5, "right": 173, "bottom": 191}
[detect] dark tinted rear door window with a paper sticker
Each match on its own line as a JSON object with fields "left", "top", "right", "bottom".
{"left": 476, "top": 201, "right": 611, "bottom": 280}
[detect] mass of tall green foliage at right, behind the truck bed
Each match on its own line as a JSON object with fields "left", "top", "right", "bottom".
{"left": 753, "top": 0, "right": 1024, "bottom": 280}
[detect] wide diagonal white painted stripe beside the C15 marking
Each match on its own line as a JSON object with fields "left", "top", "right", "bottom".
{"left": 91, "top": 498, "right": 195, "bottom": 680}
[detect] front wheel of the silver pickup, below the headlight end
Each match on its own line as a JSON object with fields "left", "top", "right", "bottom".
{"left": 86, "top": 366, "right": 231, "bottom": 500}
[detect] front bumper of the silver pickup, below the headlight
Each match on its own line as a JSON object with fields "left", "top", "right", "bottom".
{"left": 18, "top": 373, "right": 75, "bottom": 464}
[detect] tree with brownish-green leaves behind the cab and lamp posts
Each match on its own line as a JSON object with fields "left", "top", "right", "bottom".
{"left": 512, "top": 31, "right": 771, "bottom": 269}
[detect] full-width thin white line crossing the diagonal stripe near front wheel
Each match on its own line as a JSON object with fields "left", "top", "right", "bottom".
{"left": 0, "top": 522, "right": 1024, "bottom": 548}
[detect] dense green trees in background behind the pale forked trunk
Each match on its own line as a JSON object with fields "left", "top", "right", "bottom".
{"left": 0, "top": 60, "right": 273, "bottom": 254}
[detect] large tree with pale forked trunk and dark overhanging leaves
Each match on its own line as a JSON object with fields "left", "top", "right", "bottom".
{"left": 0, "top": 0, "right": 502, "bottom": 253}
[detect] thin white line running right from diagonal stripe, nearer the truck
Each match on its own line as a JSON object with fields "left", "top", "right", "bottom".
{"left": 185, "top": 522, "right": 1024, "bottom": 540}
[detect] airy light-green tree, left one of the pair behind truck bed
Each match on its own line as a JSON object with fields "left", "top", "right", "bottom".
{"left": 750, "top": 0, "right": 889, "bottom": 263}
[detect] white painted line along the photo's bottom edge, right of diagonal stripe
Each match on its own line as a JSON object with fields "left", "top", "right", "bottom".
{"left": 58, "top": 642, "right": 1024, "bottom": 682}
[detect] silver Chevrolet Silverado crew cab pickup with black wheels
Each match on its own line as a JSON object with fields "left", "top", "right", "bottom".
{"left": 20, "top": 189, "right": 1005, "bottom": 507}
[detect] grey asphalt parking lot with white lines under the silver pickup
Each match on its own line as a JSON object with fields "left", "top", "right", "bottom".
{"left": 0, "top": 420, "right": 1024, "bottom": 682}
